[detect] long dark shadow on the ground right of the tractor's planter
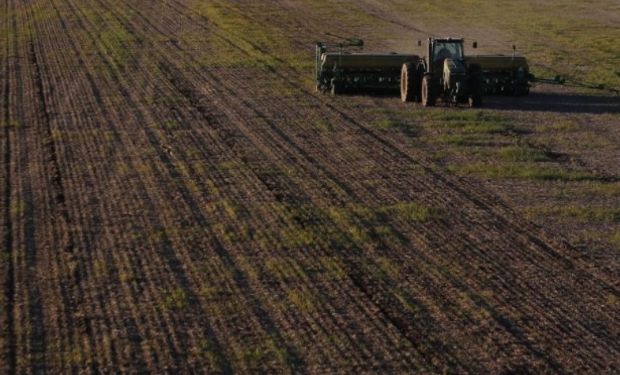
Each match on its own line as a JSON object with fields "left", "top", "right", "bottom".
{"left": 484, "top": 92, "right": 620, "bottom": 114}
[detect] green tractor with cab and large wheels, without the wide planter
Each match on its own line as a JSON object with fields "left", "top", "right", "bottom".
{"left": 400, "top": 38, "right": 484, "bottom": 107}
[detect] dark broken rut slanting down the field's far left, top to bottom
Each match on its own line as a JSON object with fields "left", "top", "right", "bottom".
{"left": 23, "top": 3, "right": 142, "bottom": 372}
